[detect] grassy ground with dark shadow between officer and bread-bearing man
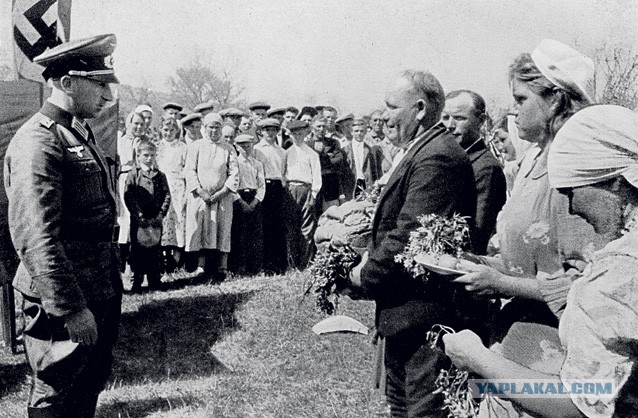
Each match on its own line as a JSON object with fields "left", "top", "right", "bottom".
{"left": 0, "top": 273, "right": 389, "bottom": 418}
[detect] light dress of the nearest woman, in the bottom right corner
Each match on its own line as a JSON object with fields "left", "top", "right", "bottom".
{"left": 559, "top": 229, "right": 638, "bottom": 417}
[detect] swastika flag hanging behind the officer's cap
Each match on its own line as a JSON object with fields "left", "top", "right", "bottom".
{"left": 12, "top": 0, "right": 71, "bottom": 82}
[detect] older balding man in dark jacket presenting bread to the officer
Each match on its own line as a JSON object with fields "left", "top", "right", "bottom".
{"left": 351, "top": 71, "right": 476, "bottom": 417}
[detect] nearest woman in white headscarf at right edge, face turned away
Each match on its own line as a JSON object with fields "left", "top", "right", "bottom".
{"left": 443, "top": 106, "right": 638, "bottom": 417}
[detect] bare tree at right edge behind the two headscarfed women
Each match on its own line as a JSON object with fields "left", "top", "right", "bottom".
{"left": 594, "top": 46, "right": 638, "bottom": 109}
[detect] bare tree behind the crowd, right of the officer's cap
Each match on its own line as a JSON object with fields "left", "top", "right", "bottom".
{"left": 168, "top": 57, "right": 243, "bottom": 108}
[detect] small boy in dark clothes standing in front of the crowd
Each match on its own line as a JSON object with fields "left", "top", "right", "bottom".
{"left": 124, "top": 141, "right": 171, "bottom": 293}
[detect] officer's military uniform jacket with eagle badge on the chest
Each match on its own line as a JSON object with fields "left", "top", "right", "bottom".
{"left": 4, "top": 102, "right": 122, "bottom": 316}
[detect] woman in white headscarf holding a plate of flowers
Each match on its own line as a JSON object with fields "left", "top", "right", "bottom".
{"left": 455, "top": 39, "right": 595, "bottom": 341}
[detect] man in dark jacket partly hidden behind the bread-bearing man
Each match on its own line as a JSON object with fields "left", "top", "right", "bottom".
{"left": 442, "top": 90, "right": 507, "bottom": 254}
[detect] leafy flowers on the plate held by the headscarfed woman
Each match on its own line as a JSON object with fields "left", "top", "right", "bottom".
{"left": 394, "top": 214, "right": 470, "bottom": 277}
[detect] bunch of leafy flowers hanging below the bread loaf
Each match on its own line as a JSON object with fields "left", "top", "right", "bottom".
{"left": 304, "top": 244, "right": 361, "bottom": 315}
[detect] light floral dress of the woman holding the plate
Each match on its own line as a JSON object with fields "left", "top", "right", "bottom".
{"left": 496, "top": 145, "right": 602, "bottom": 316}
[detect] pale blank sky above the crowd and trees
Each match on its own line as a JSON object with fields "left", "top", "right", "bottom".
{"left": 2, "top": 0, "right": 638, "bottom": 113}
